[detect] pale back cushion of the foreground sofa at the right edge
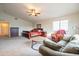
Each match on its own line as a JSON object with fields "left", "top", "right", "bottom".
{"left": 62, "top": 36, "right": 79, "bottom": 54}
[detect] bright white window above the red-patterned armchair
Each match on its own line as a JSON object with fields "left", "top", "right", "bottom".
{"left": 53, "top": 20, "right": 68, "bottom": 31}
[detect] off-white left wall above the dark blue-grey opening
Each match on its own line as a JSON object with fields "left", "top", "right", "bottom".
{"left": 0, "top": 12, "right": 33, "bottom": 35}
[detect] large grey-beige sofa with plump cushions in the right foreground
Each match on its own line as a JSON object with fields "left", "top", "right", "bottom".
{"left": 39, "top": 35, "right": 79, "bottom": 56}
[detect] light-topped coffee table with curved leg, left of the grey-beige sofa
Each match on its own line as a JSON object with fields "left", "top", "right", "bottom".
{"left": 30, "top": 36, "right": 46, "bottom": 50}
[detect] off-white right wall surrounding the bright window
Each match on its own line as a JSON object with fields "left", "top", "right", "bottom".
{"left": 37, "top": 13, "right": 79, "bottom": 35}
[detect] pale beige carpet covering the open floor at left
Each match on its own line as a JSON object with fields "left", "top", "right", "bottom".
{"left": 0, "top": 37, "right": 41, "bottom": 56}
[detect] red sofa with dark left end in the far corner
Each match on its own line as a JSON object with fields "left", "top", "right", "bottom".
{"left": 22, "top": 28, "right": 46, "bottom": 39}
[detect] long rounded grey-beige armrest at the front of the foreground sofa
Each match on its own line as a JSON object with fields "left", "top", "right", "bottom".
{"left": 39, "top": 45, "right": 78, "bottom": 56}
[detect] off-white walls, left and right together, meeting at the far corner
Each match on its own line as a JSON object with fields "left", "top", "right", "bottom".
{"left": 0, "top": 12, "right": 79, "bottom": 35}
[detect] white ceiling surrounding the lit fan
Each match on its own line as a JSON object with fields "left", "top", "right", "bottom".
{"left": 0, "top": 3, "right": 79, "bottom": 21}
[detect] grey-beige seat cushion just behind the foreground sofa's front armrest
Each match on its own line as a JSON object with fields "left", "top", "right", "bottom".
{"left": 44, "top": 39, "right": 61, "bottom": 51}
